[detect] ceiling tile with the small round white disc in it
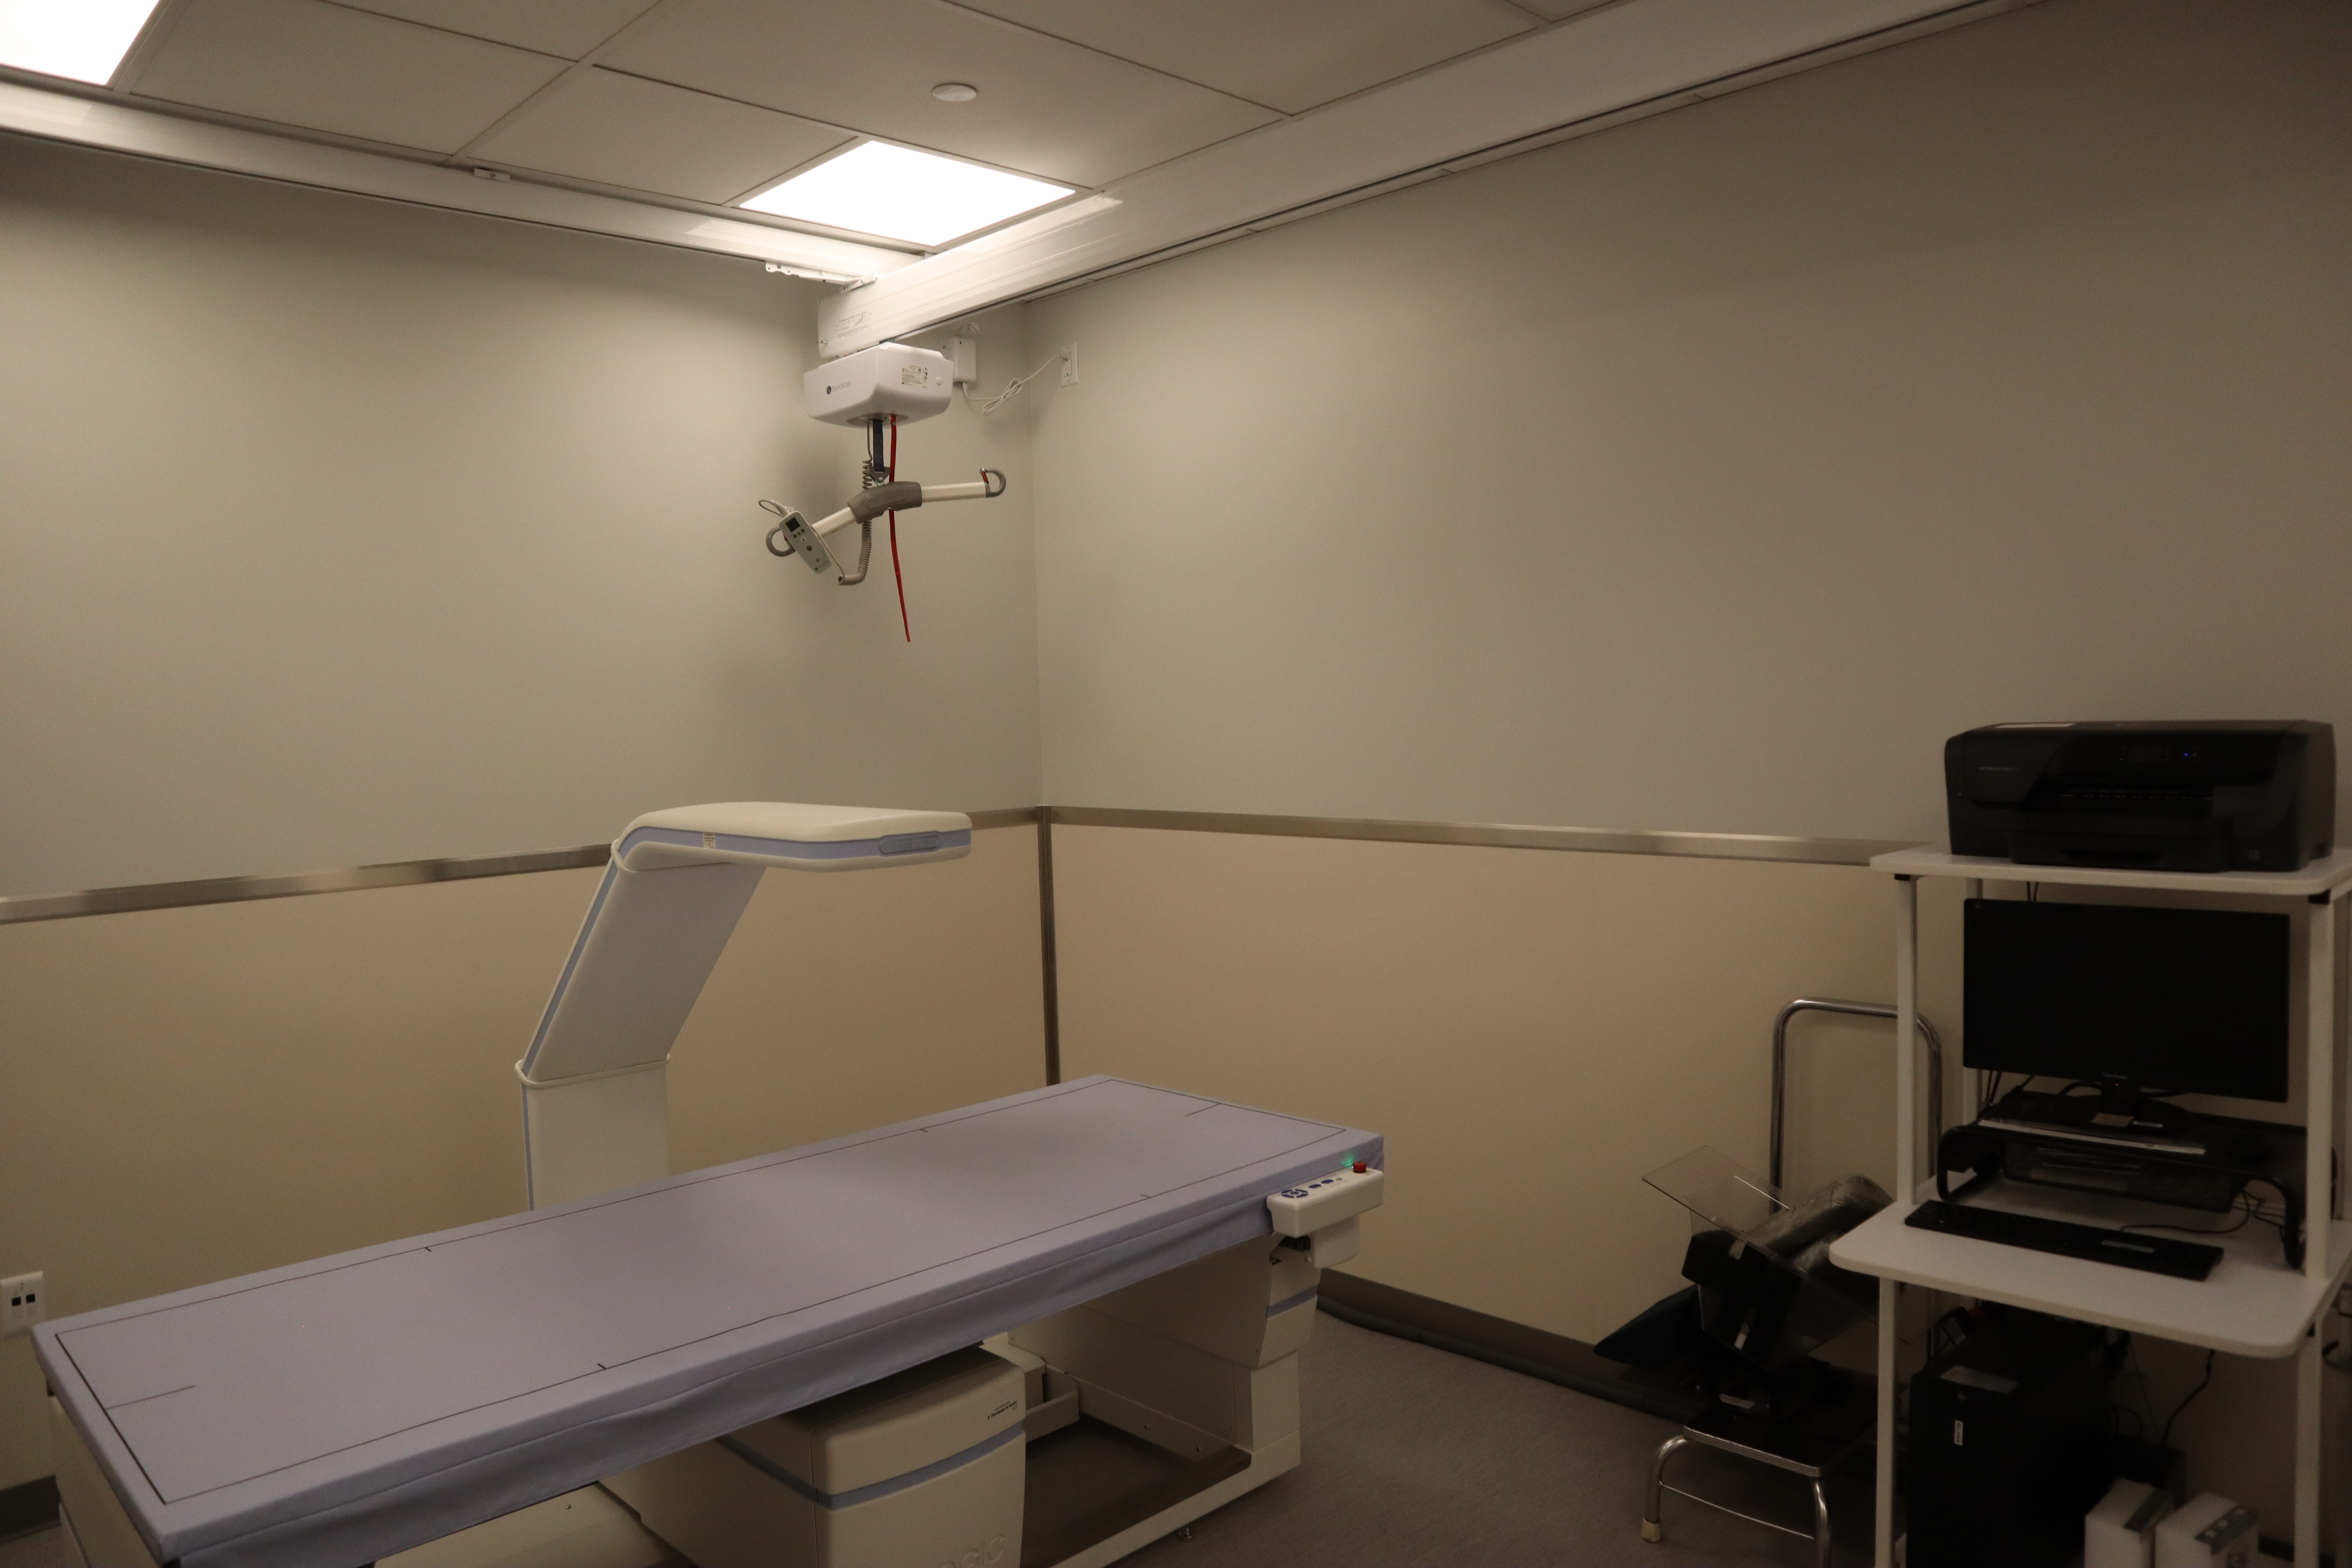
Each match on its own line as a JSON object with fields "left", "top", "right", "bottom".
{"left": 600, "top": 0, "right": 1275, "bottom": 186}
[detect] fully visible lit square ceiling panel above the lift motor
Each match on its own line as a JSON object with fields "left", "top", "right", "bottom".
{"left": 741, "top": 141, "right": 1070, "bottom": 245}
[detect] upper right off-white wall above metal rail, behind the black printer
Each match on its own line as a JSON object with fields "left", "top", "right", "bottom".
{"left": 1033, "top": 0, "right": 2352, "bottom": 839}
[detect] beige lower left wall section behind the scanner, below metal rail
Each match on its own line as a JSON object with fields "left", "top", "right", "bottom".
{"left": 0, "top": 828, "right": 1044, "bottom": 1486}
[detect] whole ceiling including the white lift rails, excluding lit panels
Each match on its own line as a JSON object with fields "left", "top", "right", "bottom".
{"left": 0, "top": 0, "right": 2034, "bottom": 315}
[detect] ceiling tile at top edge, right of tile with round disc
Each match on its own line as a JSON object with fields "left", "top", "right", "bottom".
{"left": 962, "top": 0, "right": 1538, "bottom": 113}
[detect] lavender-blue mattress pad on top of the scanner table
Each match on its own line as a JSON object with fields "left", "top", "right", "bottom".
{"left": 35, "top": 1077, "right": 1383, "bottom": 1568}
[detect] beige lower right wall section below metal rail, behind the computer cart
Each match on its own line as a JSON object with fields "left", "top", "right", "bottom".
{"left": 1054, "top": 828, "right": 2293, "bottom": 1535}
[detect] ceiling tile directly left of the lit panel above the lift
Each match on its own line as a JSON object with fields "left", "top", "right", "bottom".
{"left": 470, "top": 66, "right": 849, "bottom": 202}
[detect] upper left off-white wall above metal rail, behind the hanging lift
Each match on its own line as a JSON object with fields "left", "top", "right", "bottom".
{"left": 0, "top": 139, "right": 1037, "bottom": 893}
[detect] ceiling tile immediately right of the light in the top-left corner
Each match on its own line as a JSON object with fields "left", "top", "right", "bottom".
{"left": 132, "top": 0, "right": 564, "bottom": 153}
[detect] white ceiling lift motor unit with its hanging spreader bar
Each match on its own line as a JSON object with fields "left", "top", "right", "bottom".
{"left": 760, "top": 343, "right": 1004, "bottom": 588}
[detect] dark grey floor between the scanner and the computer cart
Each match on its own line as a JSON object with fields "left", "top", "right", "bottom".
{"left": 0, "top": 1314, "right": 1870, "bottom": 1568}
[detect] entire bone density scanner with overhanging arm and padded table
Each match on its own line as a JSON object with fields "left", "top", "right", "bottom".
{"left": 35, "top": 804, "right": 1383, "bottom": 1568}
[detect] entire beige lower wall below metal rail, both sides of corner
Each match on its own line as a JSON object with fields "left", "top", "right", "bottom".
{"left": 0, "top": 828, "right": 2291, "bottom": 1533}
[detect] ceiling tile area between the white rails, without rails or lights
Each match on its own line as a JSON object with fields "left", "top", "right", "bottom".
{"left": 87, "top": 0, "right": 1597, "bottom": 242}
